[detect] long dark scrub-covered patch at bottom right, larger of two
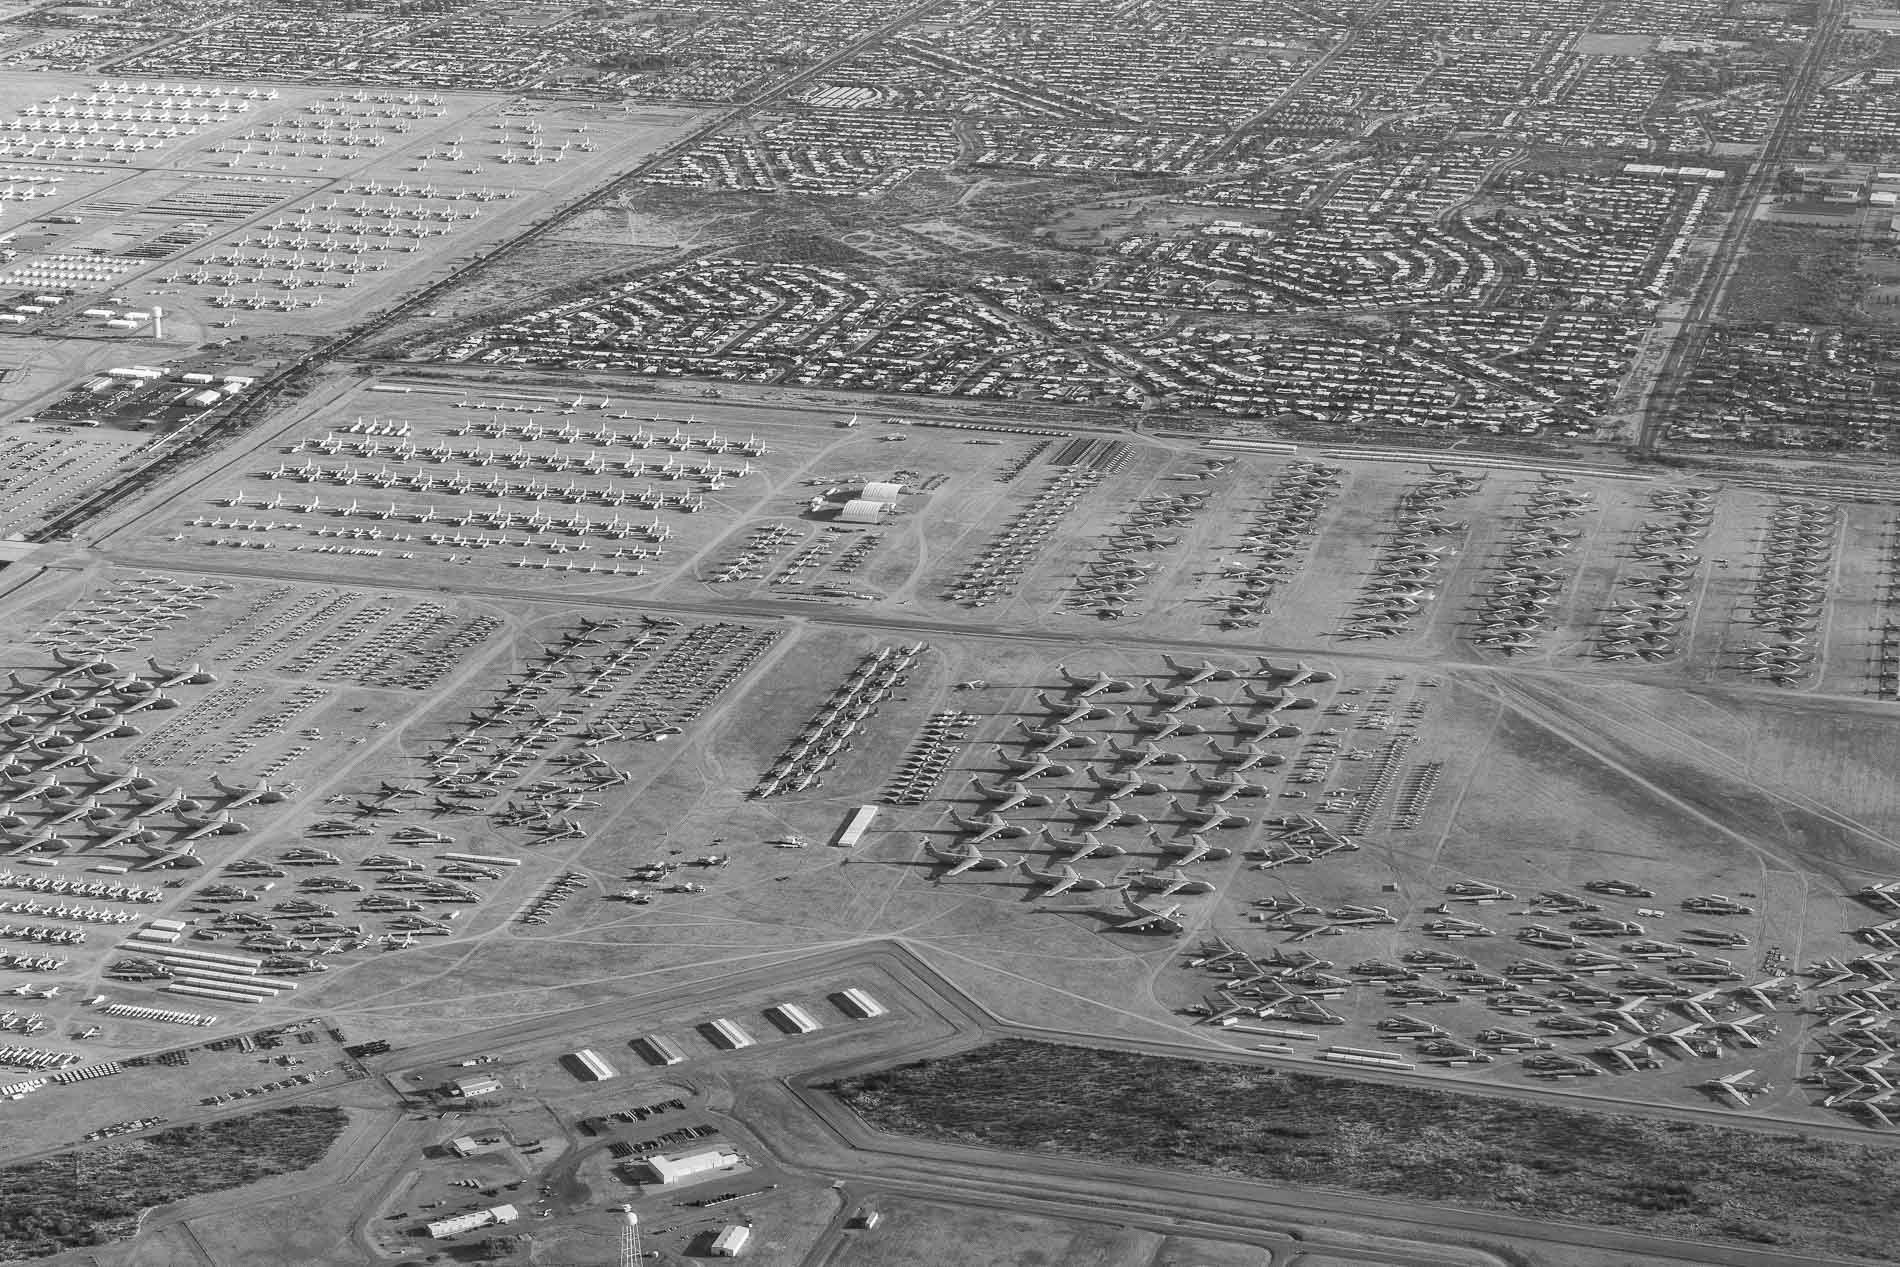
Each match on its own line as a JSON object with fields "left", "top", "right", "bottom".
{"left": 825, "top": 1039, "right": 1900, "bottom": 1263}
